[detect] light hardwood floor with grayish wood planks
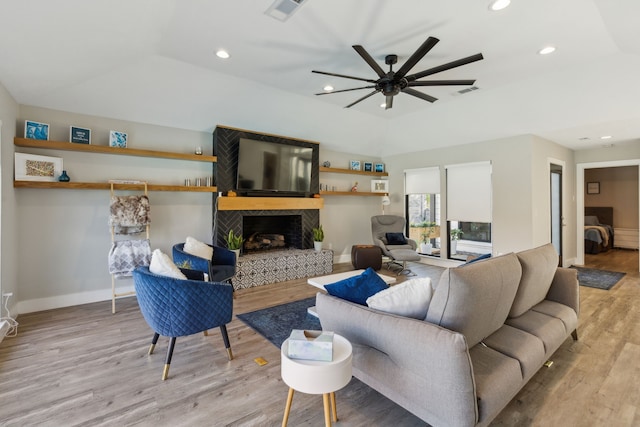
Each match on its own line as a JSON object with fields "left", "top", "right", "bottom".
{"left": 0, "top": 251, "right": 640, "bottom": 426}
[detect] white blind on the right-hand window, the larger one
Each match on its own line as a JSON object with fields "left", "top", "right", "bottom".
{"left": 446, "top": 162, "right": 491, "bottom": 222}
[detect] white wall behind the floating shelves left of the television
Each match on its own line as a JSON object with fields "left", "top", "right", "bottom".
{"left": 14, "top": 106, "right": 212, "bottom": 312}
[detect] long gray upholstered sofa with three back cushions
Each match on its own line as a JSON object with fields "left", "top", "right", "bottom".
{"left": 316, "top": 244, "right": 579, "bottom": 426}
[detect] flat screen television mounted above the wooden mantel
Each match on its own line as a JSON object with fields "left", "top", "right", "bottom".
{"left": 236, "top": 138, "right": 313, "bottom": 197}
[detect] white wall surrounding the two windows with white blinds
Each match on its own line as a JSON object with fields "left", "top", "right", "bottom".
{"left": 384, "top": 135, "right": 575, "bottom": 256}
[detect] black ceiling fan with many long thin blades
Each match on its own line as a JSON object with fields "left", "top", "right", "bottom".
{"left": 311, "top": 37, "right": 483, "bottom": 110}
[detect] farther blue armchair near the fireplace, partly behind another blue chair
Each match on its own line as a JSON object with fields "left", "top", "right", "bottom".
{"left": 172, "top": 243, "right": 236, "bottom": 283}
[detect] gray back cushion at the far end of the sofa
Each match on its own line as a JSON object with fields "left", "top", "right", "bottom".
{"left": 509, "top": 243, "right": 558, "bottom": 317}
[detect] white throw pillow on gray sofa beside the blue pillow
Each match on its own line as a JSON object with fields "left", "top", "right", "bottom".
{"left": 367, "top": 277, "right": 433, "bottom": 320}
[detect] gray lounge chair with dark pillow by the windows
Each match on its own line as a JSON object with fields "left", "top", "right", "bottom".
{"left": 371, "top": 215, "right": 420, "bottom": 275}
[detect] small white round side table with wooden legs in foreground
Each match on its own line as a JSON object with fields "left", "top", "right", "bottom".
{"left": 280, "top": 334, "right": 351, "bottom": 427}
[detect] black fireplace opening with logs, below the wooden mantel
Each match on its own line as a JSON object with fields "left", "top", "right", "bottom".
{"left": 242, "top": 215, "right": 303, "bottom": 252}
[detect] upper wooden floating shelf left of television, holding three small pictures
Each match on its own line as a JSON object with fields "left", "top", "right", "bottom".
{"left": 13, "top": 138, "right": 218, "bottom": 163}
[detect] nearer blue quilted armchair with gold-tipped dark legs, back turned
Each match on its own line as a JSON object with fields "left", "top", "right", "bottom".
{"left": 133, "top": 267, "right": 233, "bottom": 380}
